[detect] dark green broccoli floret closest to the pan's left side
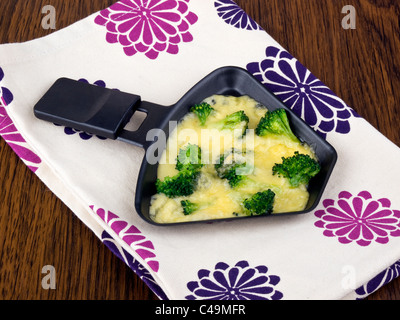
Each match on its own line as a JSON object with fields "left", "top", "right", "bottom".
{"left": 156, "top": 170, "right": 200, "bottom": 198}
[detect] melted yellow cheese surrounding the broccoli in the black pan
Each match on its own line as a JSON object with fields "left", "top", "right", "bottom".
{"left": 150, "top": 95, "right": 315, "bottom": 223}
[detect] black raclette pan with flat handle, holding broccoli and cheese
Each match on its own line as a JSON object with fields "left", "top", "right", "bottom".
{"left": 34, "top": 67, "right": 337, "bottom": 226}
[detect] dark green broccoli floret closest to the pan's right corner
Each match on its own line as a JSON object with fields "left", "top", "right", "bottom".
{"left": 272, "top": 151, "right": 321, "bottom": 187}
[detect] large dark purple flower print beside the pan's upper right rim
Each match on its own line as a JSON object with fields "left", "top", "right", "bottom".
{"left": 247, "top": 46, "right": 358, "bottom": 137}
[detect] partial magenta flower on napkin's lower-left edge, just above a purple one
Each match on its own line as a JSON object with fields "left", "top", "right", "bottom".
{"left": 90, "top": 206, "right": 160, "bottom": 272}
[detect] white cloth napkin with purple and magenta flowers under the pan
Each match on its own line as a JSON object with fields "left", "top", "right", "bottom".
{"left": 0, "top": 0, "right": 400, "bottom": 300}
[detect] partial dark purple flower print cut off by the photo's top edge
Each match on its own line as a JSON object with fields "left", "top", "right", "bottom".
{"left": 214, "top": 0, "right": 261, "bottom": 30}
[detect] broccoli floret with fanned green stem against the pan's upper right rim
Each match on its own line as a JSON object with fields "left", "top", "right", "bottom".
{"left": 256, "top": 109, "right": 299, "bottom": 142}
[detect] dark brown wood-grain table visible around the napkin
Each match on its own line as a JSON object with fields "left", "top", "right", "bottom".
{"left": 0, "top": 0, "right": 400, "bottom": 300}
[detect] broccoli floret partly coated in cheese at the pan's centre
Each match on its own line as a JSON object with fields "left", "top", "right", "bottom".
{"left": 215, "top": 150, "right": 252, "bottom": 188}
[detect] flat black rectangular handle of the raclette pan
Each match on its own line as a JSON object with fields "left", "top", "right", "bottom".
{"left": 34, "top": 78, "right": 168, "bottom": 148}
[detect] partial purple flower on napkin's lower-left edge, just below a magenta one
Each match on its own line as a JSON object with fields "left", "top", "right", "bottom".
{"left": 101, "top": 231, "right": 168, "bottom": 300}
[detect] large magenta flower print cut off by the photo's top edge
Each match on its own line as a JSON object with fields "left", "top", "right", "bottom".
{"left": 95, "top": 0, "right": 198, "bottom": 60}
